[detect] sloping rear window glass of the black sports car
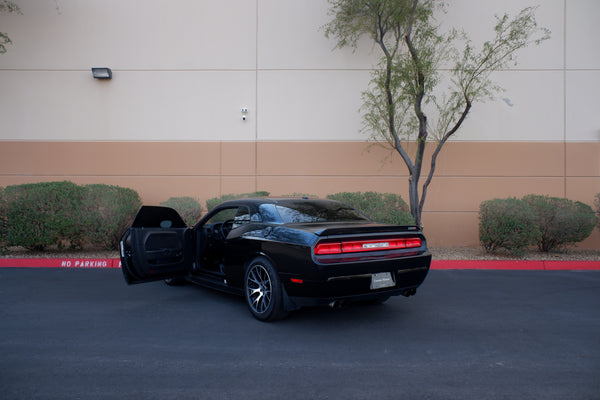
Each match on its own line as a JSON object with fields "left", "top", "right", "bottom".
{"left": 261, "top": 200, "right": 368, "bottom": 224}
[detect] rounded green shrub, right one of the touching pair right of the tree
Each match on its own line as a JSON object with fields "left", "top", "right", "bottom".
{"left": 523, "top": 194, "right": 598, "bottom": 252}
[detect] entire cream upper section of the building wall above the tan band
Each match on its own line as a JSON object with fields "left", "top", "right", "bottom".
{"left": 0, "top": 0, "right": 600, "bottom": 142}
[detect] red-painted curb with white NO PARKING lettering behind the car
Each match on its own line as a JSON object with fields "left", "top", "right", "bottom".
{"left": 0, "top": 258, "right": 600, "bottom": 271}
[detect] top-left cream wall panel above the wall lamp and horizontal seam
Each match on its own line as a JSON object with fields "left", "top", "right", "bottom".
{"left": 0, "top": 0, "right": 256, "bottom": 70}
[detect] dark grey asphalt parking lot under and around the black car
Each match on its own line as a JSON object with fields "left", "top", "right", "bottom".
{"left": 0, "top": 268, "right": 600, "bottom": 400}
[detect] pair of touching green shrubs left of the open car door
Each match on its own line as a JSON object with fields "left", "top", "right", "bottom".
{"left": 0, "top": 181, "right": 141, "bottom": 251}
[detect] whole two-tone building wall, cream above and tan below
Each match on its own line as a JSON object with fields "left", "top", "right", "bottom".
{"left": 0, "top": 0, "right": 600, "bottom": 248}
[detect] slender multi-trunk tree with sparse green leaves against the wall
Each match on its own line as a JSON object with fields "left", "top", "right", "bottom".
{"left": 325, "top": 0, "right": 550, "bottom": 225}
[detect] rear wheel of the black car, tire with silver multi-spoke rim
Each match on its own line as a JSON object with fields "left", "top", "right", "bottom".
{"left": 244, "top": 257, "right": 287, "bottom": 321}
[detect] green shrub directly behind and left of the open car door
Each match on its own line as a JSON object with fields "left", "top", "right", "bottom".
{"left": 79, "top": 184, "right": 142, "bottom": 250}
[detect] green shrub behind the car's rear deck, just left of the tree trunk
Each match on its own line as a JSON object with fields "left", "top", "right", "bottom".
{"left": 327, "top": 192, "right": 415, "bottom": 225}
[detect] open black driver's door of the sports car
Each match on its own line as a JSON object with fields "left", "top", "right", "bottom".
{"left": 120, "top": 206, "right": 194, "bottom": 284}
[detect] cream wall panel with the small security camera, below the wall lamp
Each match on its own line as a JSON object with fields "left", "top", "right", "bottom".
{"left": 0, "top": 71, "right": 256, "bottom": 141}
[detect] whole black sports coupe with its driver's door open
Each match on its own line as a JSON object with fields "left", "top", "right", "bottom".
{"left": 121, "top": 198, "right": 431, "bottom": 321}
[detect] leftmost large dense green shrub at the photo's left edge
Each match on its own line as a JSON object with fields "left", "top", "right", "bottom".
{"left": 3, "top": 181, "right": 85, "bottom": 250}
